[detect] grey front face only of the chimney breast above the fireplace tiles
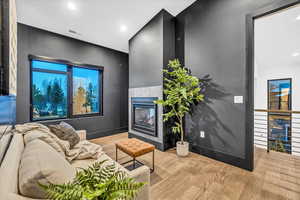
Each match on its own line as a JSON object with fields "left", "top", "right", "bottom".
{"left": 129, "top": 12, "right": 164, "bottom": 88}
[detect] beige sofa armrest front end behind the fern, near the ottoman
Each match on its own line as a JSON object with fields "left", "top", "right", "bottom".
{"left": 129, "top": 165, "right": 150, "bottom": 200}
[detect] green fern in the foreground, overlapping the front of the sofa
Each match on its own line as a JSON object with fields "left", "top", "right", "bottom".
{"left": 40, "top": 160, "right": 145, "bottom": 200}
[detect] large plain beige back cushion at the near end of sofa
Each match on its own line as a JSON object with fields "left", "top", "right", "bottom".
{"left": 19, "top": 139, "right": 76, "bottom": 199}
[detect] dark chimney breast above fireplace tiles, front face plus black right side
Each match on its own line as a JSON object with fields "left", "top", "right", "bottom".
{"left": 129, "top": 10, "right": 175, "bottom": 88}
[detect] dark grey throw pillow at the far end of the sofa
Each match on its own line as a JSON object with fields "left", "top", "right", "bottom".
{"left": 49, "top": 122, "right": 80, "bottom": 148}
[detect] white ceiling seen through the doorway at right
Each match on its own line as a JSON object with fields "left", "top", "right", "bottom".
{"left": 254, "top": 4, "right": 300, "bottom": 70}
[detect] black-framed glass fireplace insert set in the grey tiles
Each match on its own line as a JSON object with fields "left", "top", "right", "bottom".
{"left": 131, "top": 97, "right": 158, "bottom": 137}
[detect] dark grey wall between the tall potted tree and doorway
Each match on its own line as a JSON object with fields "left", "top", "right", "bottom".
{"left": 176, "top": 0, "right": 280, "bottom": 170}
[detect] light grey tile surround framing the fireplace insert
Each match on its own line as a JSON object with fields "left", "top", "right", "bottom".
{"left": 128, "top": 86, "right": 164, "bottom": 150}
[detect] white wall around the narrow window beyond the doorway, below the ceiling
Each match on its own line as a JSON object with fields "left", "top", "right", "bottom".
{"left": 254, "top": 62, "right": 300, "bottom": 156}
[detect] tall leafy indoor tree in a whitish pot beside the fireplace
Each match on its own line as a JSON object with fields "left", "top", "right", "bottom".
{"left": 155, "top": 59, "right": 204, "bottom": 156}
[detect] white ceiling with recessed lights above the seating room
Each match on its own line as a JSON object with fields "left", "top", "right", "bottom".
{"left": 17, "top": 0, "right": 195, "bottom": 52}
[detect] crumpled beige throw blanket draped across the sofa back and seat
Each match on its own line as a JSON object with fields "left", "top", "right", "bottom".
{"left": 15, "top": 123, "right": 103, "bottom": 162}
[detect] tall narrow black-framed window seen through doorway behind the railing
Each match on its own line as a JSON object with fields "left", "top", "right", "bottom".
{"left": 268, "top": 79, "right": 292, "bottom": 153}
